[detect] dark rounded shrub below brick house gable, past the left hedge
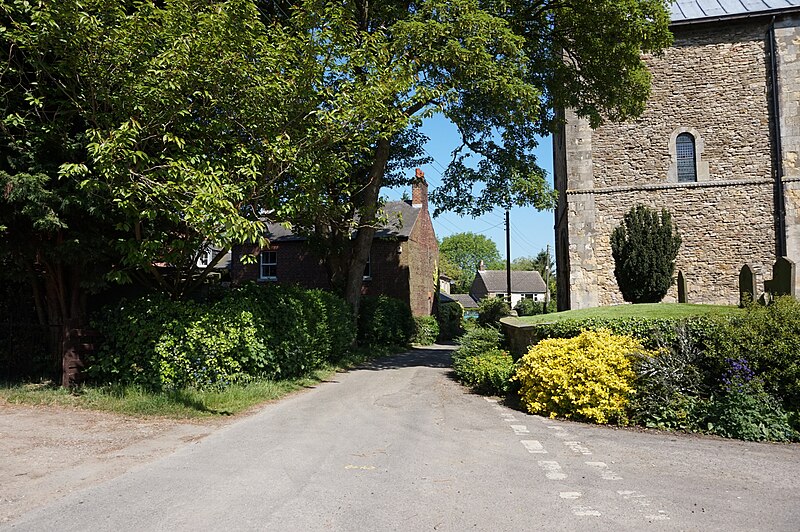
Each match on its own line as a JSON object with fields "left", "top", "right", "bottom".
{"left": 358, "top": 296, "right": 415, "bottom": 347}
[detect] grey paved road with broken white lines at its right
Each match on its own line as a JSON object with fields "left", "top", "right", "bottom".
{"left": 2, "top": 349, "right": 800, "bottom": 531}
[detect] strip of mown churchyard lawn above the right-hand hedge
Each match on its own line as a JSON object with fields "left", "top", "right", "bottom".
{"left": 512, "top": 303, "right": 741, "bottom": 324}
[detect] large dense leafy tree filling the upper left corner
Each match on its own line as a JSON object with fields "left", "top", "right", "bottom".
{"left": 0, "top": 0, "right": 317, "bottom": 364}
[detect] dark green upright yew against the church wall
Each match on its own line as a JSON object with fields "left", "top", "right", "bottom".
{"left": 611, "top": 205, "right": 681, "bottom": 303}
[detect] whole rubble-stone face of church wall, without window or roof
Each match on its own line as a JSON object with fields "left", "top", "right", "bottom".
{"left": 556, "top": 21, "right": 780, "bottom": 308}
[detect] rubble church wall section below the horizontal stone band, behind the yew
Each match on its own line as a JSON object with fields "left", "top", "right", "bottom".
{"left": 594, "top": 182, "right": 775, "bottom": 305}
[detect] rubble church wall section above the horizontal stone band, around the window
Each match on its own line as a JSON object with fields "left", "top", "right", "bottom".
{"left": 592, "top": 23, "right": 772, "bottom": 188}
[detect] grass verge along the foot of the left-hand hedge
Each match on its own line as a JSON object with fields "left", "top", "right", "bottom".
{"left": 0, "top": 349, "right": 398, "bottom": 419}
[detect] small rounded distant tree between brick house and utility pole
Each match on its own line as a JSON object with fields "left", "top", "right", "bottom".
{"left": 439, "top": 233, "right": 500, "bottom": 294}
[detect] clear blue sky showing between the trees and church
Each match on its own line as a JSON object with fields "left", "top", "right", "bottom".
{"left": 383, "top": 116, "right": 555, "bottom": 260}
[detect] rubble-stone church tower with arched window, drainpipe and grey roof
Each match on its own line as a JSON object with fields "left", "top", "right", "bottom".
{"left": 553, "top": 0, "right": 800, "bottom": 310}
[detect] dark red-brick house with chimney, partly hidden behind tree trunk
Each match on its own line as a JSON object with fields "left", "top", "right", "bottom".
{"left": 231, "top": 170, "right": 439, "bottom": 316}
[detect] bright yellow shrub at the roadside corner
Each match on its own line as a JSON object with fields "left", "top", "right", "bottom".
{"left": 514, "top": 330, "right": 645, "bottom": 424}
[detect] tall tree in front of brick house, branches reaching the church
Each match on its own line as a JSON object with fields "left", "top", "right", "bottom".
{"left": 261, "top": 0, "right": 670, "bottom": 316}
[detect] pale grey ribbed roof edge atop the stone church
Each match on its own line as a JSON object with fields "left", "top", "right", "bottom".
{"left": 671, "top": 0, "right": 800, "bottom": 23}
